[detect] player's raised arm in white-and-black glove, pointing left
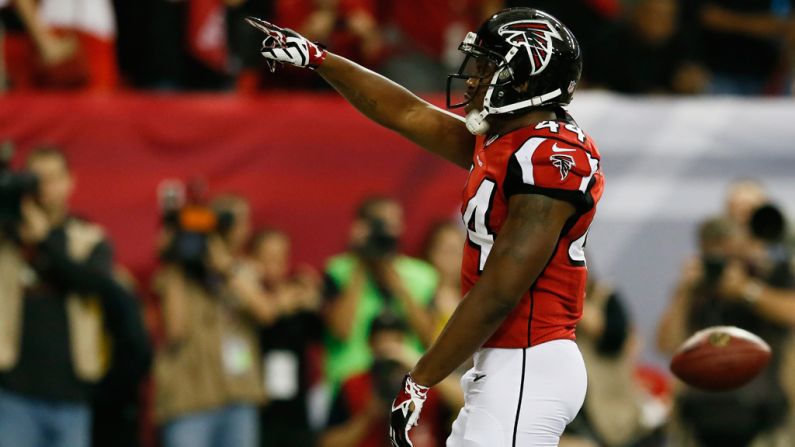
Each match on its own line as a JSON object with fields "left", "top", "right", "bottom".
{"left": 248, "top": 18, "right": 475, "bottom": 169}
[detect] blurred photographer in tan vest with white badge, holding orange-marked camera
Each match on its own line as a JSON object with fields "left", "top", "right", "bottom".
{"left": 155, "top": 196, "right": 276, "bottom": 447}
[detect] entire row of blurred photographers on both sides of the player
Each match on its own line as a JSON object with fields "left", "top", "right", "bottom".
{"left": 0, "top": 143, "right": 795, "bottom": 447}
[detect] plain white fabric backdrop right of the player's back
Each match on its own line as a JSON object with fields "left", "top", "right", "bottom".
{"left": 570, "top": 92, "right": 795, "bottom": 368}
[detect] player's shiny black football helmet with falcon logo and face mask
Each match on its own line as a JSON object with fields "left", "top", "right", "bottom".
{"left": 447, "top": 8, "right": 582, "bottom": 133}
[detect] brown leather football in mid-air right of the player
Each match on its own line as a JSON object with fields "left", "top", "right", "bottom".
{"left": 671, "top": 326, "right": 770, "bottom": 391}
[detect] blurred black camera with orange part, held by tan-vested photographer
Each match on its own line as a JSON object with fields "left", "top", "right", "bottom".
{"left": 158, "top": 180, "right": 234, "bottom": 278}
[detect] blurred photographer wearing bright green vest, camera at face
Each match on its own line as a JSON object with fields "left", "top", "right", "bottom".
{"left": 324, "top": 197, "right": 438, "bottom": 394}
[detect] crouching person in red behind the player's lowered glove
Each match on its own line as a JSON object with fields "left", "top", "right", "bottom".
{"left": 318, "top": 313, "right": 464, "bottom": 447}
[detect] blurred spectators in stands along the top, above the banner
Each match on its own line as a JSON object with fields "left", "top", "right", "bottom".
{"left": 0, "top": 0, "right": 795, "bottom": 95}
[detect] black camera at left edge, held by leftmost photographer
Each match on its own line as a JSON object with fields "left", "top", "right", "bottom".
{"left": 0, "top": 142, "right": 39, "bottom": 228}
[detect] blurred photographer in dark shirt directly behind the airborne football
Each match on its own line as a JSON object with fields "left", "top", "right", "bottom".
{"left": 657, "top": 215, "right": 795, "bottom": 447}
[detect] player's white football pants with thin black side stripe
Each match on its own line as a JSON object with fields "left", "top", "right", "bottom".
{"left": 447, "top": 340, "right": 587, "bottom": 447}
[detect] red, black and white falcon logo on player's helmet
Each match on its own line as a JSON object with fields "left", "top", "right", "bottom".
{"left": 497, "top": 20, "right": 563, "bottom": 75}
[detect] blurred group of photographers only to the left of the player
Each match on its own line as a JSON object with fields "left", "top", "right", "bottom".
{"left": 0, "top": 147, "right": 464, "bottom": 447}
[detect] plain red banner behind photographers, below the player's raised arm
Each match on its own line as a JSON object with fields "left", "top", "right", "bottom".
{"left": 0, "top": 94, "right": 466, "bottom": 277}
